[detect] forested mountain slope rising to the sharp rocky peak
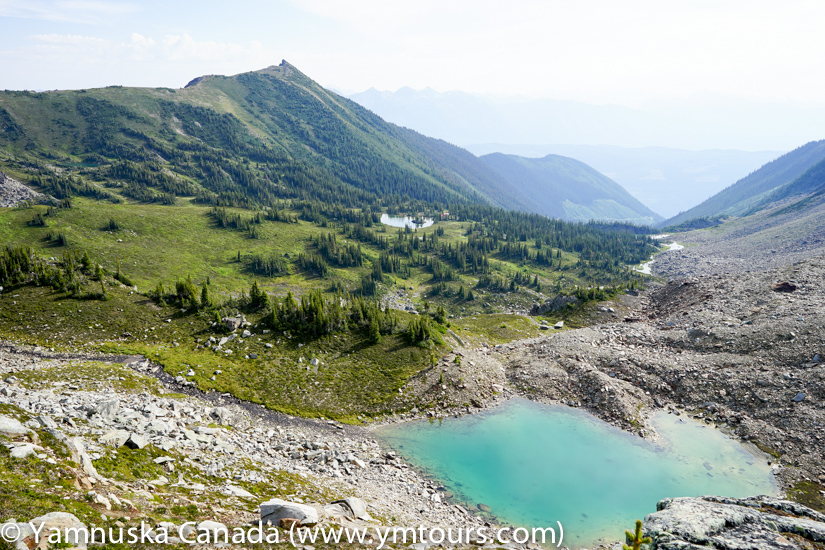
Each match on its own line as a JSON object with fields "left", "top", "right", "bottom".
{"left": 0, "top": 62, "right": 516, "bottom": 211}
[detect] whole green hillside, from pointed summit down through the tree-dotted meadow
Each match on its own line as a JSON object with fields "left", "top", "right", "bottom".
{"left": 0, "top": 64, "right": 655, "bottom": 419}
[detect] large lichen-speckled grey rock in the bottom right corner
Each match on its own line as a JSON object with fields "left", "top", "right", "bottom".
{"left": 644, "top": 496, "right": 825, "bottom": 550}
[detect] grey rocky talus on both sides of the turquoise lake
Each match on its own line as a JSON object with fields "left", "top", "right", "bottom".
{"left": 0, "top": 237, "right": 825, "bottom": 550}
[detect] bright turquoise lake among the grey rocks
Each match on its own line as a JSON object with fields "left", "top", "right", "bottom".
{"left": 375, "top": 399, "right": 777, "bottom": 548}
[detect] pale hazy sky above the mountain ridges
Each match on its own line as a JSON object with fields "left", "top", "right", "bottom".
{"left": 6, "top": 0, "right": 825, "bottom": 104}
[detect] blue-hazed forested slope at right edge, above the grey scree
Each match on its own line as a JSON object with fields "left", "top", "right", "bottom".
{"left": 662, "top": 140, "right": 825, "bottom": 230}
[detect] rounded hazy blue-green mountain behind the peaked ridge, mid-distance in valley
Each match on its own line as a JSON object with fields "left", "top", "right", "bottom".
{"left": 481, "top": 153, "right": 662, "bottom": 224}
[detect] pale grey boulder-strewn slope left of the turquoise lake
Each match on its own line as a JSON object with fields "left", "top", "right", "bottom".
{"left": 0, "top": 345, "right": 490, "bottom": 544}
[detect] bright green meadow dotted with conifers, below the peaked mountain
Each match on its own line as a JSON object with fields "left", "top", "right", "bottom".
{"left": 0, "top": 192, "right": 650, "bottom": 419}
